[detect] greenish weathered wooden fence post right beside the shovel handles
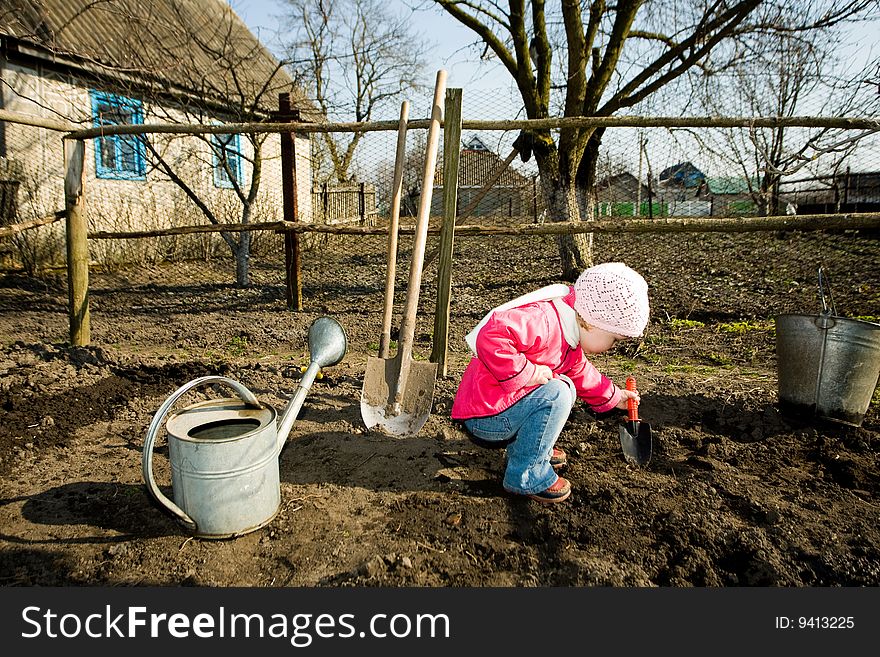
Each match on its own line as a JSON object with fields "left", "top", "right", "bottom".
{"left": 431, "top": 89, "right": 461, "bottom": 376}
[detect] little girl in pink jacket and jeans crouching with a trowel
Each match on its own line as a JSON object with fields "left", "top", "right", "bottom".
{"left": 452, "top": 262, "right": 649, "bottom": 503}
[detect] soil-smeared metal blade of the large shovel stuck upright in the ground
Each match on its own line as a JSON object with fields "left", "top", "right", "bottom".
{"left": 361, "top": 356, "right": 437, "bottom": 436}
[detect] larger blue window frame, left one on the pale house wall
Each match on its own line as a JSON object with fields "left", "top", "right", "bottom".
{"left": 91, "top": 91, "right": 146, "bottom": 180}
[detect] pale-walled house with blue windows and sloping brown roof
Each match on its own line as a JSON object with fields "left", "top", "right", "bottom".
{"left": 0, "top": 0, "right": 321, "bottom": 264}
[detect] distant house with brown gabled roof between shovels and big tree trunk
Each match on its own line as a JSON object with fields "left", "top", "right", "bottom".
{"left": 422, "top": 136, "right": 536, "bottom": 219}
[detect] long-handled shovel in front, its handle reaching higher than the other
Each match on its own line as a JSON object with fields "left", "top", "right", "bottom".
{"left": 361, "top": 70, "right": 446, "bottom": 436}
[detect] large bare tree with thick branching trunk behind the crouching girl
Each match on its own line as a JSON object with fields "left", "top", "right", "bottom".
{"left": 422, "top": 0, "right": 876, "bottom": 279}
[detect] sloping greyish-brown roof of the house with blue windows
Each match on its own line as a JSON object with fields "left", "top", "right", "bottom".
{"left": 0, "top": 0, "right": 320, "bottom": 121}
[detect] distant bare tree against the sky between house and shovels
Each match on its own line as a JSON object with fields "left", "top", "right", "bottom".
{"left": 276, "top": 0, "right": 424, "bottom": 183}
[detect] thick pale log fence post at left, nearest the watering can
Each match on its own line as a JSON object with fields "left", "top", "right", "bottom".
{"left": 64, "top": 139, "right": 91, "bottom": 346}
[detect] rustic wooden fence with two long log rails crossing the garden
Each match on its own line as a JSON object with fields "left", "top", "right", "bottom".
{"left": 0, "top": 104, "right": 880, "bottom": 366}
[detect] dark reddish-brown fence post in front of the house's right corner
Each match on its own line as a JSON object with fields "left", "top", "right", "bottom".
{"left": 278, "top": 93, "right": 302, "bottom": 310}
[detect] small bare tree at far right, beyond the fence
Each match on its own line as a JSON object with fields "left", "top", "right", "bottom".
{"left": 701, "top": 7, "right": 880, "bottom": 215}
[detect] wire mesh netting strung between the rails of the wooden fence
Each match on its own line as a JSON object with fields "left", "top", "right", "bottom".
{"left": 0, "top": 86, "right": 880, "bottom": 358}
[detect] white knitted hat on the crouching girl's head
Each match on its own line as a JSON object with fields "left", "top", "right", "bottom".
{"left": 574, "top": 262, "right": 650, "bottom": 338}
